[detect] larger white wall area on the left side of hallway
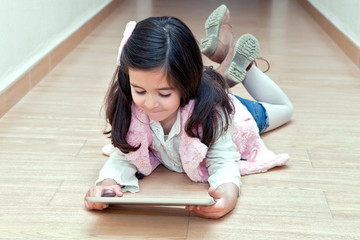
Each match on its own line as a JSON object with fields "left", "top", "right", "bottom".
{"left": 0, "top": 0, "right": 111, "bottom": 92}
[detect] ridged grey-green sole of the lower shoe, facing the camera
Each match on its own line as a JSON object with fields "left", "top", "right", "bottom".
{"left": 224, "top": 33, "right": 260, "bottom": 83}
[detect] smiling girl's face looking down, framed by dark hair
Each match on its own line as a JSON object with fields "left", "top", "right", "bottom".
{"left": 129, "top": 69, "right": 180, "bottom": 131}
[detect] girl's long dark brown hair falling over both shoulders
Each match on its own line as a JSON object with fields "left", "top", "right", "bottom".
{"left": 104, "top": 17, "right": 233, "bottom": 153}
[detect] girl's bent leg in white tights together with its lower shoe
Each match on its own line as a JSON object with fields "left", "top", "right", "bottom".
{"left": 216, "top": 34, "right": 293, "bottom": 131}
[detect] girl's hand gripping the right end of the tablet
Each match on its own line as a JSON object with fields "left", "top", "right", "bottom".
{"left": 186, "top": 183, "right": 239, "bottom": 219}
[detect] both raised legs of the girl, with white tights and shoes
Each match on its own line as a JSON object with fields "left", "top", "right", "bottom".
{"left": 200, "top": 5, "right": 293, "bottom": 132}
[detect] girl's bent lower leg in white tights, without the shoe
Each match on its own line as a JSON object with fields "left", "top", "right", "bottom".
{"left": 242, "top": 64, "right": 293, "bottom": 132}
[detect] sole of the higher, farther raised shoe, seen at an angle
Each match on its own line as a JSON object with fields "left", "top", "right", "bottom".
{"left": 200, "top": 4, "right": 227, "bottom": 57}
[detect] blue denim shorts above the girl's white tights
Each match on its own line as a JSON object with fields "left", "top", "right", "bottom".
{"left": 234, "top": 95, "right": 269, "bottom": 134}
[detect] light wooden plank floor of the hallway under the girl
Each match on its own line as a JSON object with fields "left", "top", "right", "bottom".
{"left": 0, "top": 0, "right": 360, "bottom": 240}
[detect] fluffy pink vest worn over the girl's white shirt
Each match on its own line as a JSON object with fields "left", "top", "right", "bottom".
{"left": 110, "top": 95, "right": 289, "bottom": 182}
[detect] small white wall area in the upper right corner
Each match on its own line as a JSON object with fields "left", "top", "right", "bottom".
{"left": 309, "top": 0, "right": 360, "bottom": 48}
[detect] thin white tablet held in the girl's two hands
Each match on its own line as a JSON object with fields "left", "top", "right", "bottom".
{"left": 87, "top": 197, "right": 215, "bottom": 206}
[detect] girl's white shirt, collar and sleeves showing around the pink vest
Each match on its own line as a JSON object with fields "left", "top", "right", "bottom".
{"left": 96, "top": 111, "right": 241, "bottom": 193}
